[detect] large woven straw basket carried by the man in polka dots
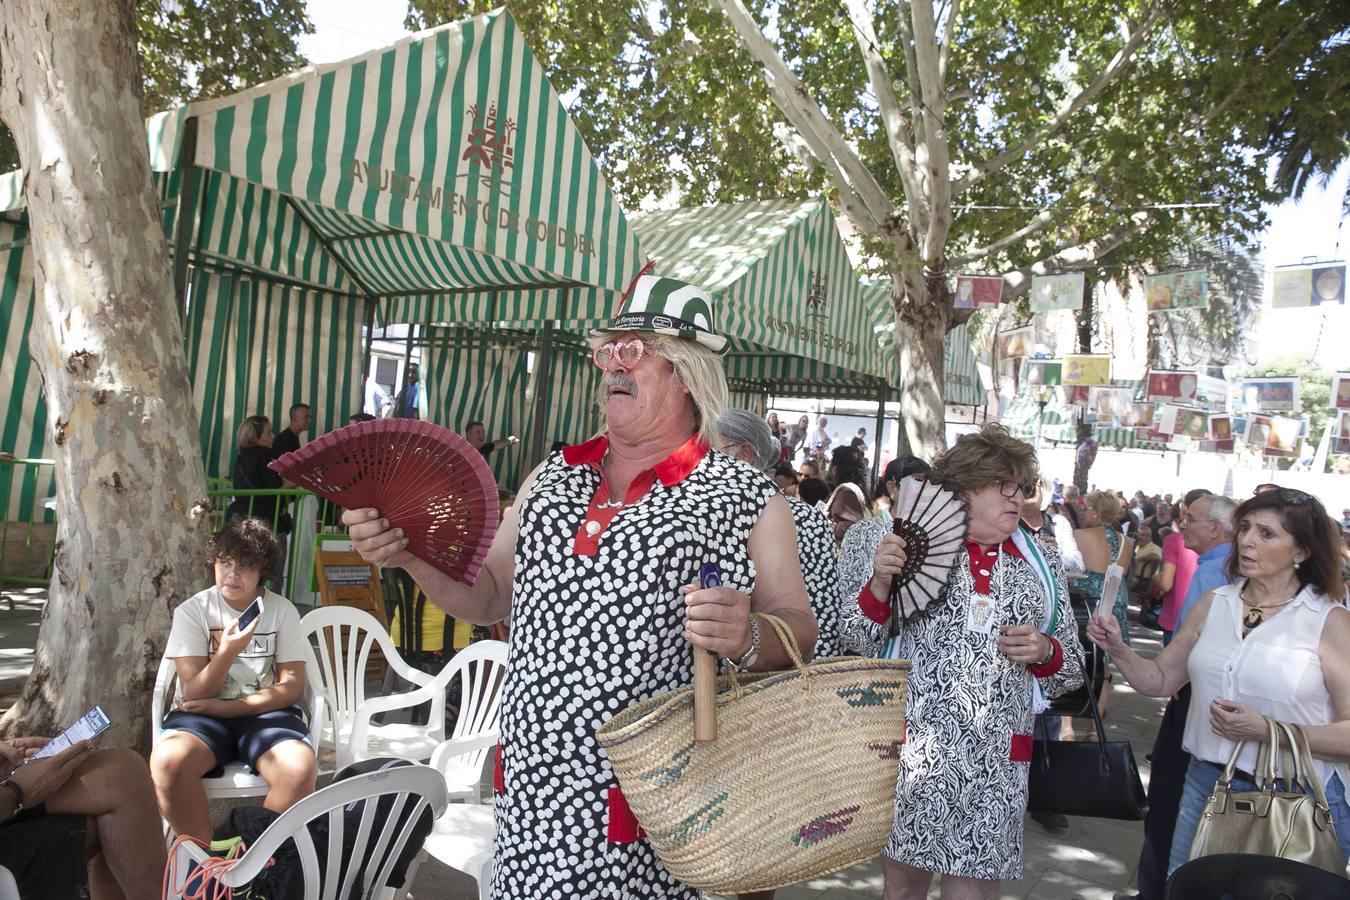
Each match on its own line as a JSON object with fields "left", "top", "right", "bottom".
{"left": 597, "top": 614, "right": 910, "bottom": 895}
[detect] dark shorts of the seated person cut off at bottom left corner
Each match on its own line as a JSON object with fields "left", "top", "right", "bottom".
{"left": 0, "top": 804, "right": 88, "bottom": 897}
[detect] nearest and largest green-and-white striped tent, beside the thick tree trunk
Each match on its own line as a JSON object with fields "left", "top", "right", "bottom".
{"left": 0, "top": 9, "right": 640, "bottom": 510}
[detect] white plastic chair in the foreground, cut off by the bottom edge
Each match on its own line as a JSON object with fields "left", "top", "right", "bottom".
{"left": 165, "top": 765, "right": 447, "bottom": 900}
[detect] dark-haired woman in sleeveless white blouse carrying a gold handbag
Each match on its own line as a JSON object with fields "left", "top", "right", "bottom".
{"left": 1088, "top": 488, "right": 1350, "bottom": 873}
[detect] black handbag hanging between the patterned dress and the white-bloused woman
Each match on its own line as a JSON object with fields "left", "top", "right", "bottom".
{"left": 1026, "top": 623, "right": 1149, "bottom": 822}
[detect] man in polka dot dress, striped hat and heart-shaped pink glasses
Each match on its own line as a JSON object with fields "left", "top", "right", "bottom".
{"left": 343, "top": 277, "right": 817, "bottom": 900}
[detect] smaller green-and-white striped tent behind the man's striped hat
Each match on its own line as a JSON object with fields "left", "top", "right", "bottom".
{"left": 432, "top": 200, "right": 907, "bottom": 472}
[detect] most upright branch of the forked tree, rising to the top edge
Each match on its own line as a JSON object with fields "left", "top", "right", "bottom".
{"left": 910, "top": 0, "right": 952, "bottom": 264}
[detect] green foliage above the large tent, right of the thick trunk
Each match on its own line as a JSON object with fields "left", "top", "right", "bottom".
{"left": 0, "top": 0, "right": 315, "bottom": 173}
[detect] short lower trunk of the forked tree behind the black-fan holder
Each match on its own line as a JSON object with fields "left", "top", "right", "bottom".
{"left": 892, "top": 275, "right": 950, "bottom": 463}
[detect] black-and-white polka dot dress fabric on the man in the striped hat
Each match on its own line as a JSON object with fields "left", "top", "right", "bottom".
{"left": 493, "top": 453, "right": 776, "bottom": 900}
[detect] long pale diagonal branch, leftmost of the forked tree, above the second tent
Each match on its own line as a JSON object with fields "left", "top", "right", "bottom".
{"left": 713, "top": 0, "right": 895, "bottom": 231}
